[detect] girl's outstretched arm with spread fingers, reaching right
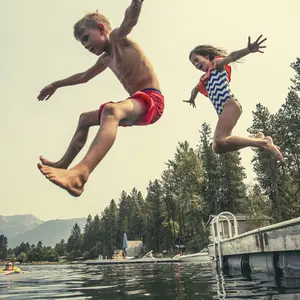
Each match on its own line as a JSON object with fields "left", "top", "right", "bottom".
{"left": 215, "top": 35, "right": 266, "bottom": 68}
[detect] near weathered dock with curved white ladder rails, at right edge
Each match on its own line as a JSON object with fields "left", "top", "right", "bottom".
{"left": 208, "top": 212, "right": 300, "bottom": 268}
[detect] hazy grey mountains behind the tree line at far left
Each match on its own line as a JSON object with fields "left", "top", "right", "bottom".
{"left": 0, "top": 215, "right": 86, "bottom": 248}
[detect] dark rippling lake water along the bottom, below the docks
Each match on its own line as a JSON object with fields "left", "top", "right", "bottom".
{"left": 0, "top": 263, "right": 300, "bottom": 300}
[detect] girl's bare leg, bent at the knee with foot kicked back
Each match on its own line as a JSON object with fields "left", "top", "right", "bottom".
{"left": 213, "top": 99, "right": 282, "bottom": 160}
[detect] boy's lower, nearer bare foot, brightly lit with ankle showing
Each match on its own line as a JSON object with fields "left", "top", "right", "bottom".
{"left": 38, "top": 163, "right": 88, "bottom": 197}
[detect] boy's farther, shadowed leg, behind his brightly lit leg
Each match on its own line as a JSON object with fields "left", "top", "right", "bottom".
{"left": 40, "top": 110, "right": 99, "bottom": 169}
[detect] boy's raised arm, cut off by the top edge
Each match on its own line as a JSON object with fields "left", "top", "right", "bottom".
{"left": 116, "top": 0, "right": 144, "bottom": 39}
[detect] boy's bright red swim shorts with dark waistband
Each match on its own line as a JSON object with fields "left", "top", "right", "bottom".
{"left": 99, "top": 88, "right": 165, "bottom": 127}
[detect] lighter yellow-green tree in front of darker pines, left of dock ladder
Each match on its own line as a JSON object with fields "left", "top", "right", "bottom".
{"left": 162, "top": 141, "right": 204, "bottom": 251}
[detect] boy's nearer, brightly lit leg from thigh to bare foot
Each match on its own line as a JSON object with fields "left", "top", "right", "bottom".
{"left": 38, "top": 99, "right": 146, "bottom": 196}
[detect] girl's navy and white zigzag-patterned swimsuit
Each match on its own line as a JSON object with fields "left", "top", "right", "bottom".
{"left": 206, "top": 69, "right": 233, "bottom": 115}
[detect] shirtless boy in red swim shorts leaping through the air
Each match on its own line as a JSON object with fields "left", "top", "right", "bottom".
{"left": 38, "top": 0, "right": 164, "bottom": 197}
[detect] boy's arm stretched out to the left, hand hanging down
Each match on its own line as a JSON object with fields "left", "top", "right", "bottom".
{"left": 38, "top": 54, "right": 107, "bottom": 101}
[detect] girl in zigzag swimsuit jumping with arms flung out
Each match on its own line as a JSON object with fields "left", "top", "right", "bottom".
{"left": 183, "top": 35, "right": 282, "bottom": 160}
